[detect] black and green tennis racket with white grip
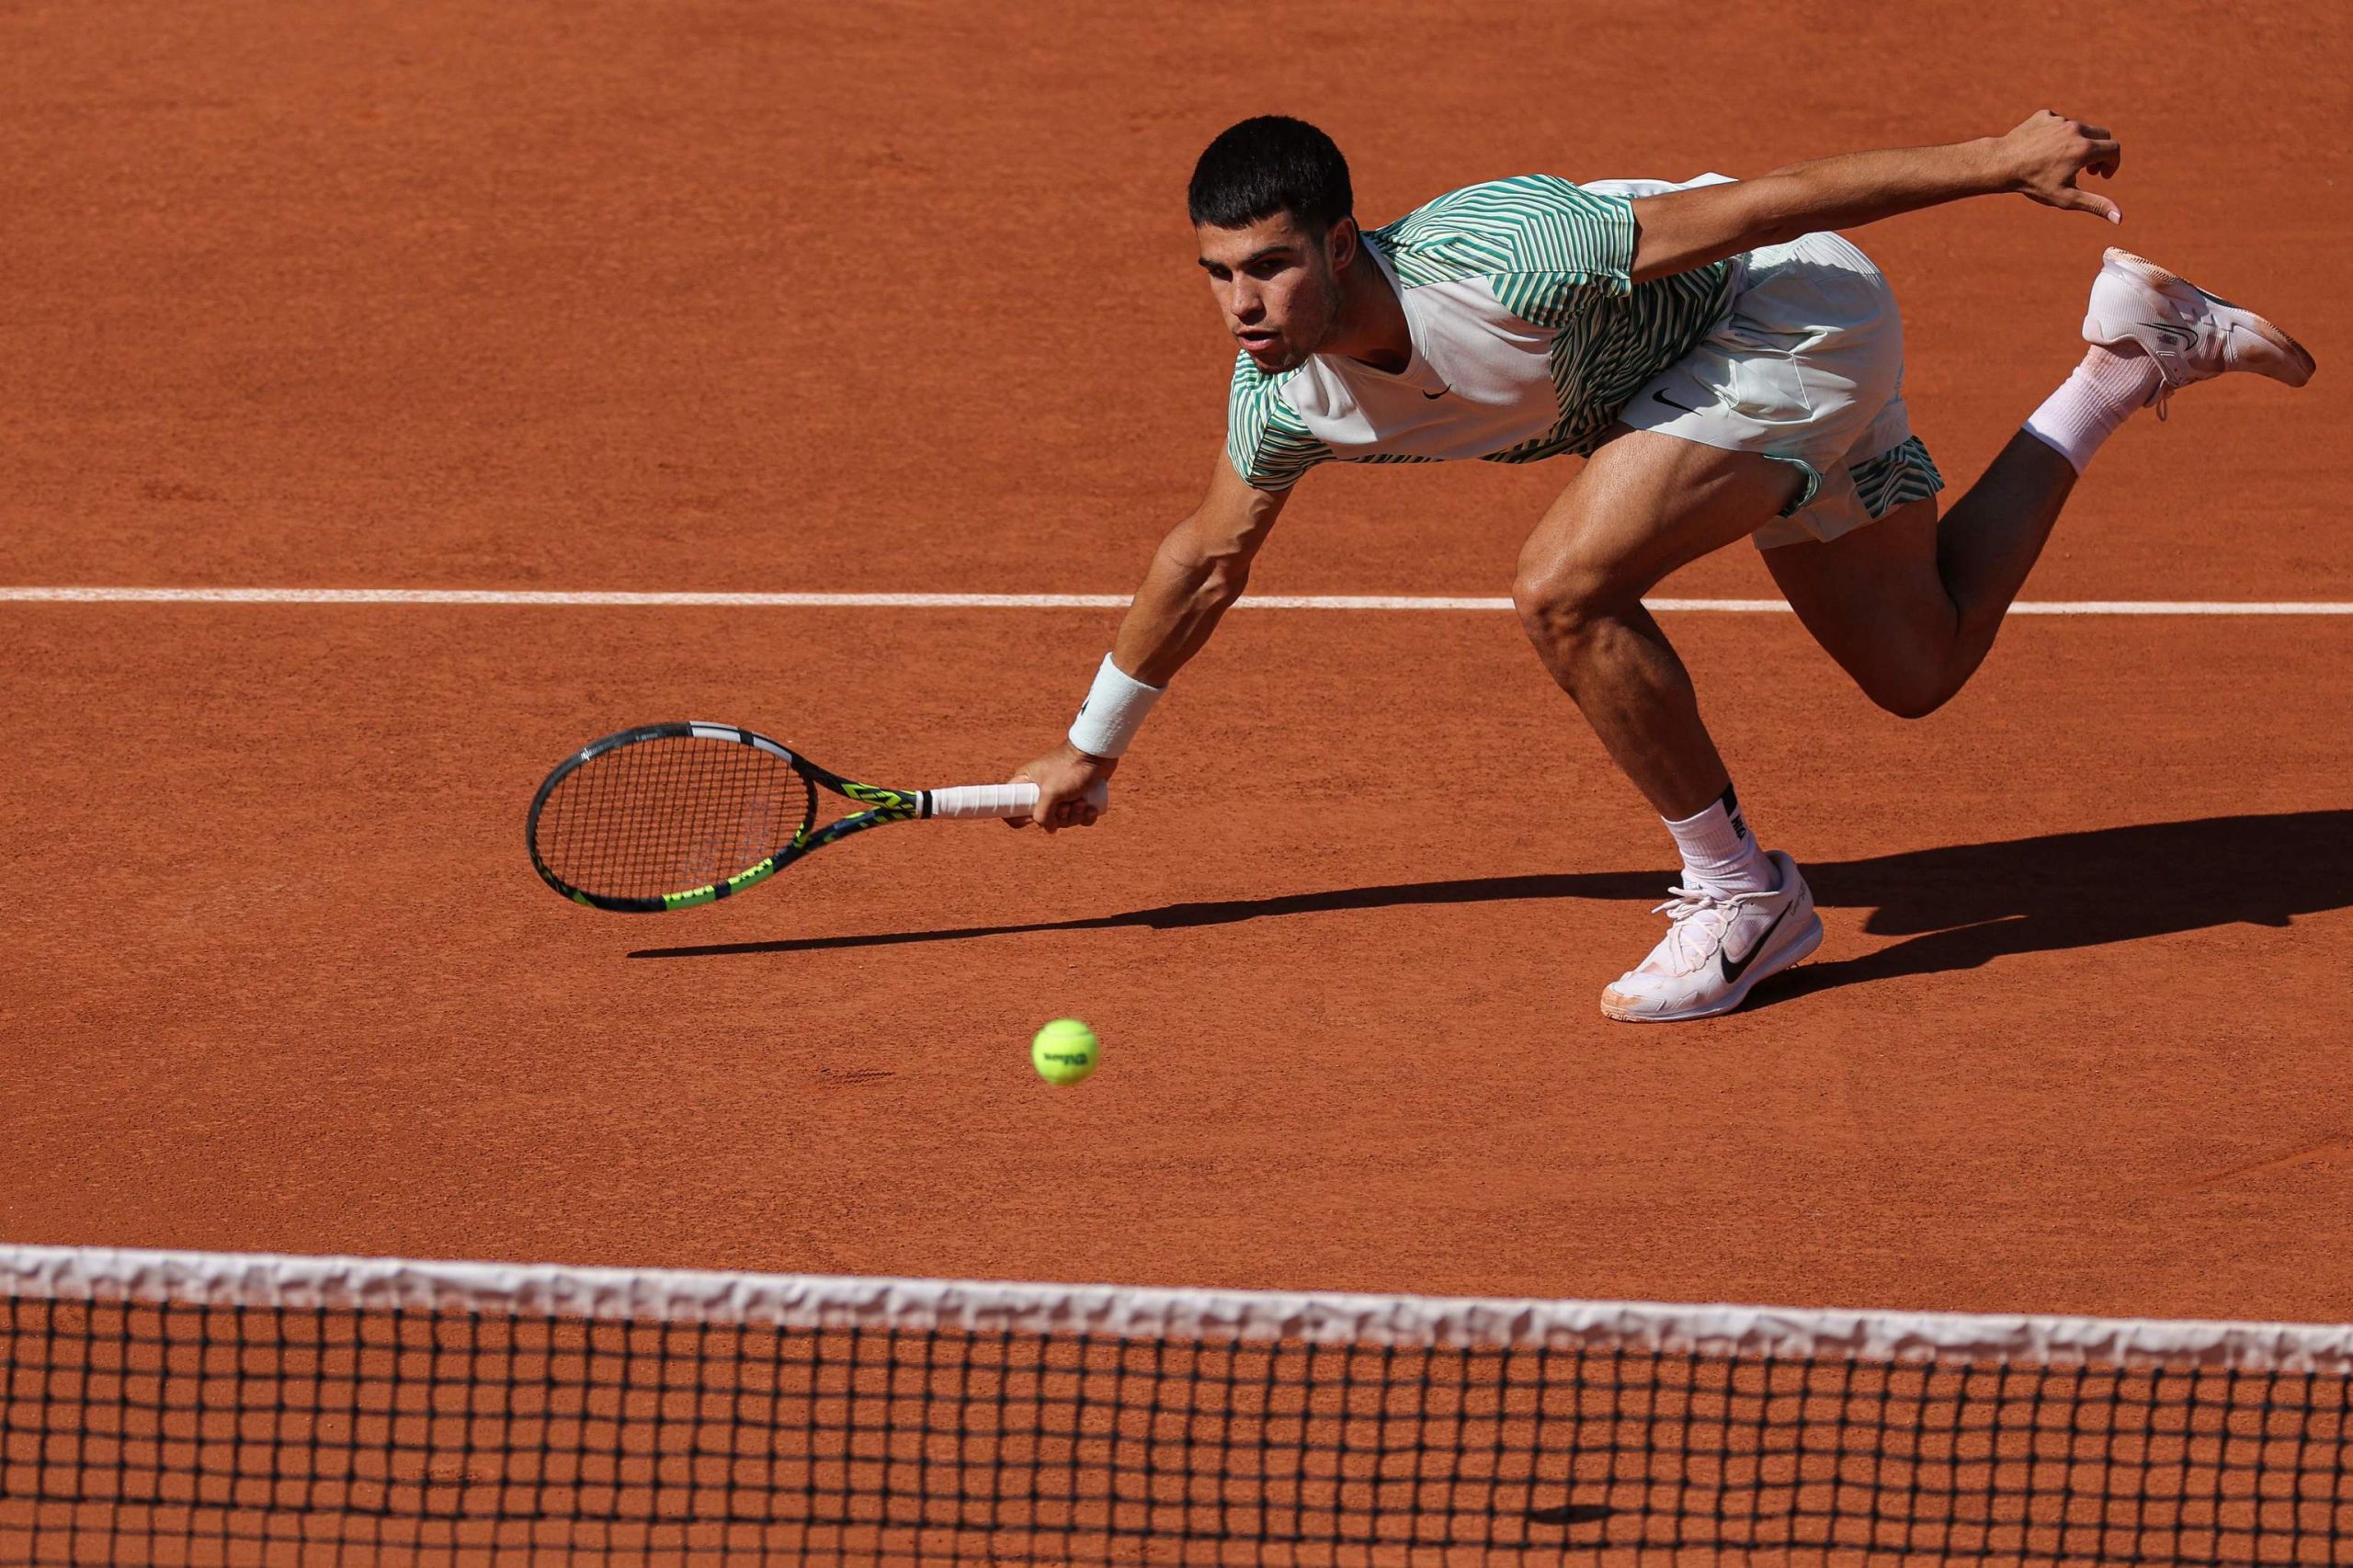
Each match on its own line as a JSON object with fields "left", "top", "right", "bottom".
{"left": 527, "top": 722, "right": 1104, "bottom": 914}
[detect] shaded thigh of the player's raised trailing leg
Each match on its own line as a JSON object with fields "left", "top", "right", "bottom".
{"left": 1760, "top": 496, "right": 1958, "bottom": 709}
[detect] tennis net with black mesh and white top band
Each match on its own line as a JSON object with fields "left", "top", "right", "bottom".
{"left": 0, "top": 1248, "right": 2353, "bottom": 1565}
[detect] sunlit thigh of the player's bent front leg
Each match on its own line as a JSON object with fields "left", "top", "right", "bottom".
{"left": 1516, "top": 426, "right": 1802, "bottom": 609}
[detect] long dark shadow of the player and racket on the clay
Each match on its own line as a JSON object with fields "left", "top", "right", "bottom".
{"left": 631, "top": 810, "right": 2353, "bottom": 1001}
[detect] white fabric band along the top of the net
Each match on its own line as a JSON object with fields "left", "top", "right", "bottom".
{"left": 0, "top": 1245, "right": 2353, "bottom": 1378}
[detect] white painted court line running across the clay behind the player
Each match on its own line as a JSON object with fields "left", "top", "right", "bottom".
{"left": 0, "top": 588, "right": 2353, "bottom": 615}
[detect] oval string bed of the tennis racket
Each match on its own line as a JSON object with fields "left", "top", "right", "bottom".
{"left": 534, "top": 734, "right": 812, "bottom": 900}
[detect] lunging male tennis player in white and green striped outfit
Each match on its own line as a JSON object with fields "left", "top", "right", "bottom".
{"left": 1017, "top": 113, "right": 2313, "bottom": 1022}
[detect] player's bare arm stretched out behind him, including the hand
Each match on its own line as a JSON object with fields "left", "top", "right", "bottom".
{"left": 1633, "top": 110, "right": 2122, "bottom": 282}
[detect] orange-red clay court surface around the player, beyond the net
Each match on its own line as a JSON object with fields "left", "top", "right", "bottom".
{"left": 0, "top": 3, "right": 2353, "bottom": 1318}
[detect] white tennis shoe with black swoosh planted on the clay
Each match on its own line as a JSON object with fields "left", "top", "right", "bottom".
{"left": 1602, "top": 850, "right": 1821, "bottom": 1024}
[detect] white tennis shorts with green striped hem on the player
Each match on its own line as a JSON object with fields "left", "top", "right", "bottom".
{"left": 1619, "top": 233, "right": 1944, "bottom": 551}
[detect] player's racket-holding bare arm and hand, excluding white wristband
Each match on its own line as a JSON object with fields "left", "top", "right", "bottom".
{"left": 1012, "top": 457, "right": 1290, "bottom": 834}
